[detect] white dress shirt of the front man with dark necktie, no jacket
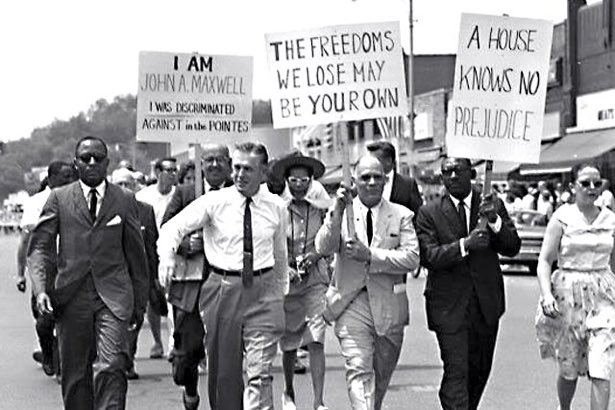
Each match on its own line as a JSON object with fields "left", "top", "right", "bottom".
{"left": 158, "top": 187, "right": 288, "bottom": 289}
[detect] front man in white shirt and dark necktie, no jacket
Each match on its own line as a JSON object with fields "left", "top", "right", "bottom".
{"left": 158, "top": 142, "right": 289, "bottom": 410}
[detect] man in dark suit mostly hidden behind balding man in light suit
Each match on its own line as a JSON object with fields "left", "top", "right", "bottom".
{"left": 366, "top": 140, "right": 423, "bottom": 215}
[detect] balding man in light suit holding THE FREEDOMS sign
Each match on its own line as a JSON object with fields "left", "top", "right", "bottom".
{"left": 316, "top": 156, "right": 419, "bottom": 410}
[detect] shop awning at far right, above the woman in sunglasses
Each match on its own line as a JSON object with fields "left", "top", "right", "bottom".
{"left": 519, "top": 128, "right": 615, "bottom": 175}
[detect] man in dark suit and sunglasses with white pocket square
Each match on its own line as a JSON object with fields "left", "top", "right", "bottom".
{"left": 28, "top": 137, "right": 148, "bottom": 410}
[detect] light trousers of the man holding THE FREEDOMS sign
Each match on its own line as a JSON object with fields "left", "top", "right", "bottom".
{"left": 335, "top": 291, "right": 404, "bottom": 410}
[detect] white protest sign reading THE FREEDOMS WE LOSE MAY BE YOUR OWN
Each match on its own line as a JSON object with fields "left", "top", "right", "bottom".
{"left": 266, "top": 22, "right": 408, "bottom": 128}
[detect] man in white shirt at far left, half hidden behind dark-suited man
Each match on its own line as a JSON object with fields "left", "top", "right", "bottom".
{"left": 17, "top": 161, "right": 77, "bottom": 376}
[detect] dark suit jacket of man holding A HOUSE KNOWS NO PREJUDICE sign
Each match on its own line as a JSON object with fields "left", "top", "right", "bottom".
{"left": 415, "top": 190, "right": 521, "bottom": 333}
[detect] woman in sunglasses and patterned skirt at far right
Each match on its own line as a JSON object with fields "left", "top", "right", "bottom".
{"left": 536, "top": 164, "right": 615, "bottom": 410}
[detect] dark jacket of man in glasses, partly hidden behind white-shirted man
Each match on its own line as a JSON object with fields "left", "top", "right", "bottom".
{"left": 161, "top": 181, "right": 233, "bottom": 312}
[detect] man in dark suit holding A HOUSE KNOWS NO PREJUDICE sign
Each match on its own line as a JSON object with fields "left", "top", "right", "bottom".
{"left": 415, "top": 158, "right": 521, "bottom": 409}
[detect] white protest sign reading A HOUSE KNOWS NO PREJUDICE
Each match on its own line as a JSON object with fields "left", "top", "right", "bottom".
{"left": 446, "top": 14, "right": 553, "bottom": 163}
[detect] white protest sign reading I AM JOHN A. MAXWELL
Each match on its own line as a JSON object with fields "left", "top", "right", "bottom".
{"left": 137, "top": 52, "right": 252, "bottom": 142}
